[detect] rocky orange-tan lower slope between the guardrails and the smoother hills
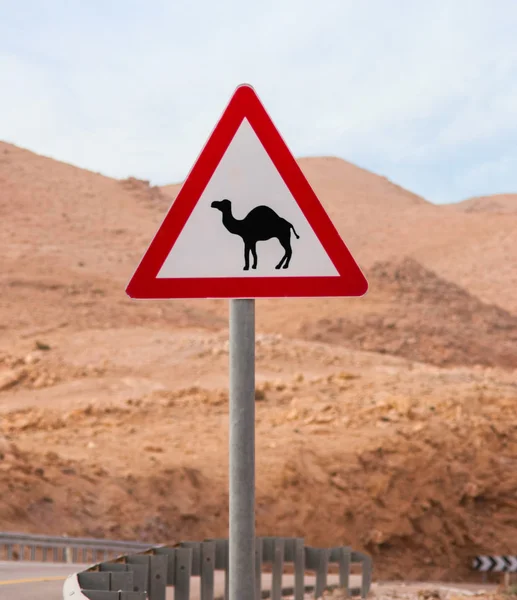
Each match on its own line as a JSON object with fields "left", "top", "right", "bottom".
{"left": 0, "top": 327, "right": 517, "bottom": 581}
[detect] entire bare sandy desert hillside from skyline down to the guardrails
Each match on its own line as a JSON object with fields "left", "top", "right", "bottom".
{"left": 0, "top": 143, "right": 517, "bottom": 579}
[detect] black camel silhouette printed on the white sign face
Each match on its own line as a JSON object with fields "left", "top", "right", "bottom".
{"left": 210, "top": 198, "right": 300, "bottom": 271}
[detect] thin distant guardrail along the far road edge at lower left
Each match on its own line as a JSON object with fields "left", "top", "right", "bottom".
{"left": 0, "top": 532, "right": 149, "bottom": 564}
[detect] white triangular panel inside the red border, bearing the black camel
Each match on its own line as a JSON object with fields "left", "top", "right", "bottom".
{"left": 157, "top": 118, "right": 339, "bottom": 278}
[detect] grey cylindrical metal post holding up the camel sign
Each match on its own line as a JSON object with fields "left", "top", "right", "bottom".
{"left": 229, "top": 299, "right": 258, "bottom": 600}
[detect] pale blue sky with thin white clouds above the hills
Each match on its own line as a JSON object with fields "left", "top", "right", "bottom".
{"left": 0, "top": 0, "right": 517, "bottom": 202}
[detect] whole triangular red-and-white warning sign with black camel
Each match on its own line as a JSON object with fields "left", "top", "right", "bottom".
{"left": 126, "top": 85, "right": 368, "bottom": 298}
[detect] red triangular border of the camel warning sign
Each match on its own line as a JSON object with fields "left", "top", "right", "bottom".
{"left": 126, "top": 85, "right": 368, "bottom": 299}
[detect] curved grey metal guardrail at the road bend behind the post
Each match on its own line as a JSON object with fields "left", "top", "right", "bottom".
{"left": 63, "top": 537, "right": 372, "bottom": 600}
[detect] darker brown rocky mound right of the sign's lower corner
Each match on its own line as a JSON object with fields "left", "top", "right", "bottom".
{"left": 299, "top": 259, "right": 517, "bottom": 369}
